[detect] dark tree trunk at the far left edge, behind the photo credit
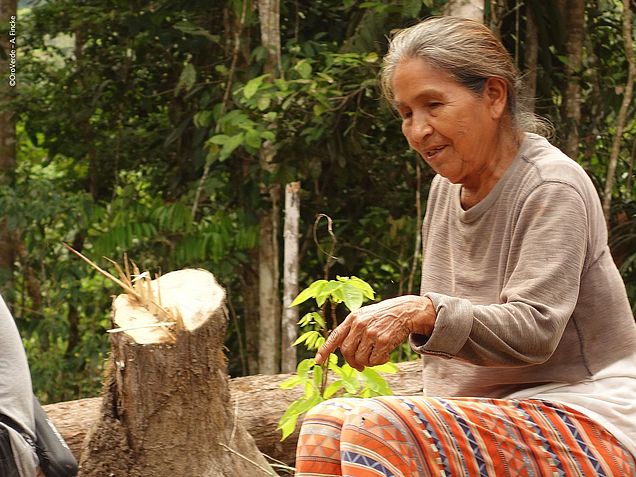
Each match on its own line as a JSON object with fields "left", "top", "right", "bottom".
{"left": 0, "top": 0, "right": 18, "bottom": 298}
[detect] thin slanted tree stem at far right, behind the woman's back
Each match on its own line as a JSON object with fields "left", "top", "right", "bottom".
{"left": 603, "top": 0, "right": 636, "bottom": 225}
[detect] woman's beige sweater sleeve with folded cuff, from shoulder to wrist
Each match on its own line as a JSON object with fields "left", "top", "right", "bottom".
{"left": 410, "top": 182, "right": 588, "bottom": 366}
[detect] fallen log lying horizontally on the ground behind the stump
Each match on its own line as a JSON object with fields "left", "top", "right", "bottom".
{"left": 44, "top": 361, "right": 422, "bottom": 466}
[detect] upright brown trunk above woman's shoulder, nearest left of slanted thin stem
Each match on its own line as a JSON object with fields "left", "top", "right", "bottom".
{"left": 559, "top": 0, "right": 585, "bottom": 159}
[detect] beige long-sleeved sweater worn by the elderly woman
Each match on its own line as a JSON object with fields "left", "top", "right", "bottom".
{"left": 410, "top": 134, "right": 636, "bottom": 397}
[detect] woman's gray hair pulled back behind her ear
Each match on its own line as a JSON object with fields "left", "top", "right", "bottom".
{"left": 380, "top": 16, "right": 550, "bottom": 134}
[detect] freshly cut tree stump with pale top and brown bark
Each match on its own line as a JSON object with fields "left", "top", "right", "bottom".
{"left": 79, "top": 270, "right": 276, "bottom": 477}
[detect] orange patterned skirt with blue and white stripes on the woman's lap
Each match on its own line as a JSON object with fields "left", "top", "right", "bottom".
{"left": 296, "top": 396, "right": 636, "bottom": 477}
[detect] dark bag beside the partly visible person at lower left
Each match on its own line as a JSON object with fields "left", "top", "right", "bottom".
{"left": 33, "top": 396, "right": 78, "bottom": 477}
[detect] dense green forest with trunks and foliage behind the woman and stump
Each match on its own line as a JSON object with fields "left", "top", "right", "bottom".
{"left": 0, "top": 0, "right": 636, "bottom": 402}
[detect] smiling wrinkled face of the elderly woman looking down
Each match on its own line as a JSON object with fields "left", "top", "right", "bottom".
{"left": 393, "top": 58, "right": 499, "bottom": 185}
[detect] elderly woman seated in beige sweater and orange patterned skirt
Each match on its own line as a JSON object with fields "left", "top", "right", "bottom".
{"left": 296, "top": 17, "right": 636, "bottom": 476}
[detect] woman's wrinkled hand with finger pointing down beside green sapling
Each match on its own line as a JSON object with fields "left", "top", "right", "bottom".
{"left": 316, "top": 295, "right": 435, "bottom": 371}
